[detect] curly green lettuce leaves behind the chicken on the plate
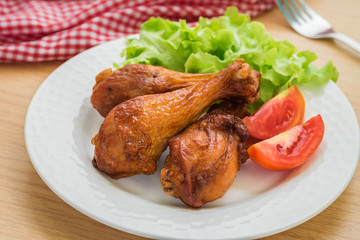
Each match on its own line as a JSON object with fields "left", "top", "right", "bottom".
{"left": 115, "top": 7, "right": 339, "bottom": 110}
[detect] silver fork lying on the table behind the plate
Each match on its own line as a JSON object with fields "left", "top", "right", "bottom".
{"left": 275, "top": 0, "right": 360, "bottom": 54}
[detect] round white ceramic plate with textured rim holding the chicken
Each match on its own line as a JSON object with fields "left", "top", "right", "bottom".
{"left": 25, "top": 39, "right": 359, "bottom": 239}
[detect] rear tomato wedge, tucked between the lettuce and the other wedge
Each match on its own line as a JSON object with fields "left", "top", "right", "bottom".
{"left": 243, "top": 85, "right": 305, "bottom": 139}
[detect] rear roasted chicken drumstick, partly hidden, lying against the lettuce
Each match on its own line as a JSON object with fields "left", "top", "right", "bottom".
{"left": 91, "top": 64, "right": 259, "bottom": 117}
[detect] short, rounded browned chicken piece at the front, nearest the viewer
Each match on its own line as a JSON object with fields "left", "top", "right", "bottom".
{"left": 160, "top": 105, "right": 248, "bottom": 207}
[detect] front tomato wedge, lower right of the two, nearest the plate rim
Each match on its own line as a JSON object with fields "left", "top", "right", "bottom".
{"left": 248, "top": 115, "right": 325, "bottom": 170}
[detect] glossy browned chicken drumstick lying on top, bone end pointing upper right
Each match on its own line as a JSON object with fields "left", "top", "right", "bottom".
{"left": 92, "top": 59, "right": 259, "bottom": 178}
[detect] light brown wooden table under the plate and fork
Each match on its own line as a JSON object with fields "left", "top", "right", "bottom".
{"left": 0, "top": 0, "right": 360, "bottom": 240}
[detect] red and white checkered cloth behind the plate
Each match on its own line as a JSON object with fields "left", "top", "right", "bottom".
{"left": 0, "top": 0, "right": 275, "bottom": 62}
